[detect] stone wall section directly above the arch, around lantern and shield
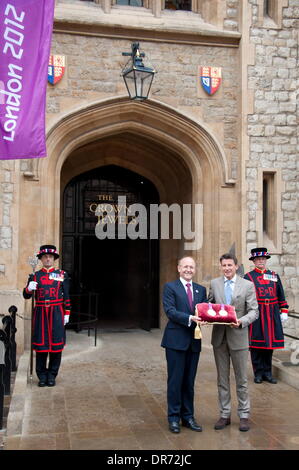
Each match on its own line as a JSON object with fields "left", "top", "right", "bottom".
{"left": 47, "top": 34, "right": 240, "bottom": 167}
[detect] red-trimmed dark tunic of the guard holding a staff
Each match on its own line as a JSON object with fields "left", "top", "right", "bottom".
{"left": 23, "top": 268, "right": 70, "bottom": 352}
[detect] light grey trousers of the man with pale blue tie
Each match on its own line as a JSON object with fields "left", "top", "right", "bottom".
{"left": 214, "top": 339, "right": 250, "bottom": 418}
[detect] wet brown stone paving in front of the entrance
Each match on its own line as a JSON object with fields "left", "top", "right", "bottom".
{"left": 4, "top": 329, "right": 299, "bottom": 450}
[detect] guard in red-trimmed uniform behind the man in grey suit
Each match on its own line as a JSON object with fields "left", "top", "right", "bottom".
{"left": 244, "top": 248, "right": 289, "bottom": 384}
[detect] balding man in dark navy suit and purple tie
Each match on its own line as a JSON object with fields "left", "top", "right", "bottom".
{"left": 161, "top": 257, "right": 207, "bottom": 433}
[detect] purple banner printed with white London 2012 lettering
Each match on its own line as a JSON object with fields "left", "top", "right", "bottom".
{"left": 0, "top": 0, "right": 55, "bottom": 160}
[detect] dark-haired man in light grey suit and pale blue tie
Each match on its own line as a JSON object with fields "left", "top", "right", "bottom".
{"left": 208, "top": 253, "right": 259, "bottom": 431}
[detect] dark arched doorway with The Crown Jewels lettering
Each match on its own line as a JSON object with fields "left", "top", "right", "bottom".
{"left": 62, "top": 165, "right": 159, "bottom": 330}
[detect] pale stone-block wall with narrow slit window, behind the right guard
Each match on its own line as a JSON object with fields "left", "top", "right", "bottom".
{"left": 246, "top": 0, "right": 299, "bottom": 342}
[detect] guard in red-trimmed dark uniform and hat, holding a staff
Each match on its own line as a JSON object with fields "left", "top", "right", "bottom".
{"left": 23, "top": 245, "right": 70, "bottom": 387}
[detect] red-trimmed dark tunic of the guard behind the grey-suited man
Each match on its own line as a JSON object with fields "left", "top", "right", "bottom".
{"left": 244, "top": 268, "right": 289, "bottom": 349}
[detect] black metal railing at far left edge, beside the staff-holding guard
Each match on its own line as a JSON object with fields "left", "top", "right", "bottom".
{"left": 0, "top": 305, "right": 18, "bottom": 429}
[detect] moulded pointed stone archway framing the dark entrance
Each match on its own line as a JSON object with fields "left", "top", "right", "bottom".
{"left": 18, "top": 98, "right": 238, "bottom": 326}
